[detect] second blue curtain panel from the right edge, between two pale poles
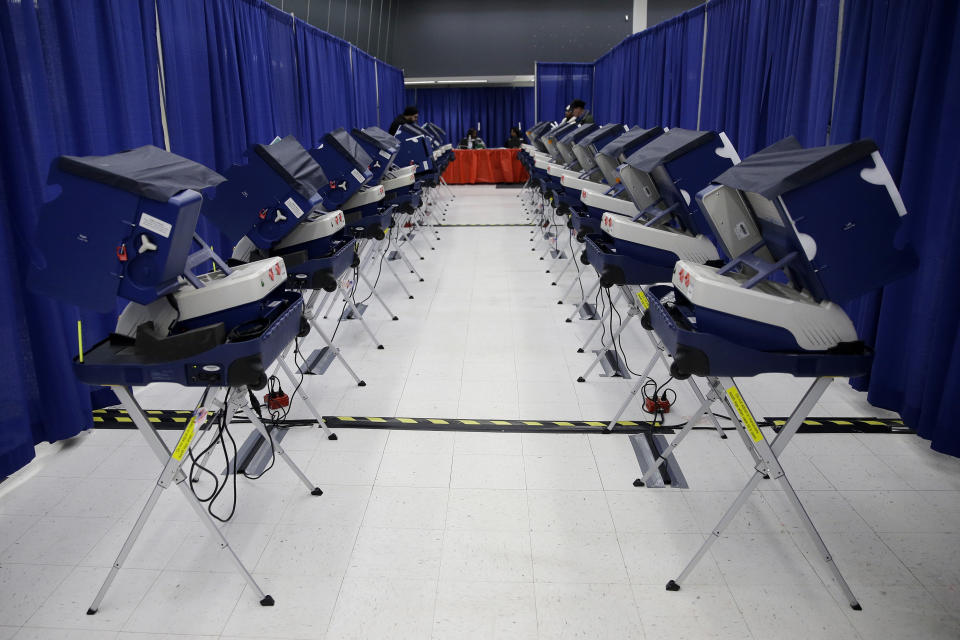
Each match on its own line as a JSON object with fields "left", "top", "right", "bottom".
{"left": 700, "top": 0, "right": 839, "bottom": 156}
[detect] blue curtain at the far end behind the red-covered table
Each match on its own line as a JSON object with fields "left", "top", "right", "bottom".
{"left": 407, "top": 87, "right": 536, "bottom": 147}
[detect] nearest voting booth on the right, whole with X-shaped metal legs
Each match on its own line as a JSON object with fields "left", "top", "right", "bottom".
{"left": 649, "top": 140, "right": 916, "bottom": 609}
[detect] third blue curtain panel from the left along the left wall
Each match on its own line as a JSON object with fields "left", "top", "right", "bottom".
{"left": 297, "top": 21, "right": 355, "bottom": 146}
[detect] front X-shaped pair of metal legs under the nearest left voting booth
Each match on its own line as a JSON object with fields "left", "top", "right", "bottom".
{"left": 87, "top": 386, "right": 274, "bottom": 615}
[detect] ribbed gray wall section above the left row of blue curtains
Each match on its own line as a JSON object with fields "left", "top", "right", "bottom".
{"left": 267, "top": 0, "right": 398, "bottom": 62}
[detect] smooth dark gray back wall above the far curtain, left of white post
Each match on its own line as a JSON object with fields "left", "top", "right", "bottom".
{"left": 388, "top": 0, "right": 633, "bottom": 77}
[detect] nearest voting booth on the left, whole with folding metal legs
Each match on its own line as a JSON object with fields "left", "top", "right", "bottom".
{"left": 29, "top": 146, "right": 322, "bottom": 615}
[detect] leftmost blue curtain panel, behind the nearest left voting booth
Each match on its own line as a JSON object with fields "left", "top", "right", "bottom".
{"left": 0, "top": 0, "right": 163, "bottom": 477}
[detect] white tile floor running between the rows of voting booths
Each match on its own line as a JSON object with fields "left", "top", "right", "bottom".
{"left": 0, "top": 186, "right": 960, "bottom": 640}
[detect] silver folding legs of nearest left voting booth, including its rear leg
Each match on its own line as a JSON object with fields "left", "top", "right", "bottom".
{"left": 87, "top": 386, "right": 323, "bottom": 615}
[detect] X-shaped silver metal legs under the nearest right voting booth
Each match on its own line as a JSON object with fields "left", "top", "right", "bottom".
{"left": 666, "top": 377, "right": 862, "bottom": 611}
